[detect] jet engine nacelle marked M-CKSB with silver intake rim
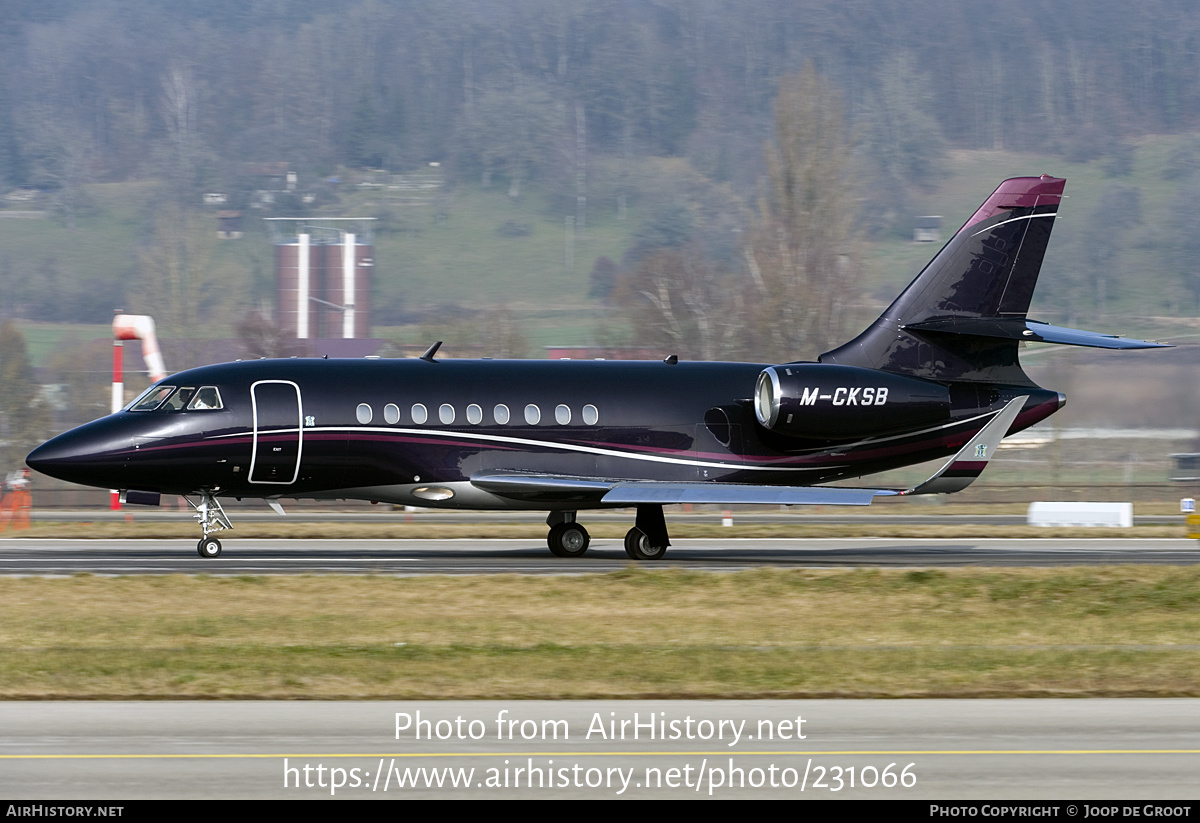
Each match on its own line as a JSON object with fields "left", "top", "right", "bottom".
{"left": 754, "top": 364, "right": 950, "bottom": 440}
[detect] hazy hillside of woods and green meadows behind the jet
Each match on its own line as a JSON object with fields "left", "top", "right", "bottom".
{"left": 0, "top": 0, "right": 1200, "bottom": 356}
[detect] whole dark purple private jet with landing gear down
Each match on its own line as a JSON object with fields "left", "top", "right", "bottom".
{"left": 28, "top": 175, "right": 1160, "bottom": 560}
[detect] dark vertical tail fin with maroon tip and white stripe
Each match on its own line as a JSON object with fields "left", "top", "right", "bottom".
{"left": 820, "top": 175, "right": 1067, "bottom": 385}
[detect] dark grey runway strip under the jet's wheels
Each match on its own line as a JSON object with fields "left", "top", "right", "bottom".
{"left": 0, "top": 535, "right": 1200, "bottom": 575}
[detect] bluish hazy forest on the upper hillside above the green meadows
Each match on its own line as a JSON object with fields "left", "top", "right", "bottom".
{"left": 0, "top": 0, "right": 1200, "bottom": 188}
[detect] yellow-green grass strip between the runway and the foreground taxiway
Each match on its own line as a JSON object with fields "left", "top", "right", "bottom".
{"left": 0, "top": 566, "right": 1200, "bottom": 699}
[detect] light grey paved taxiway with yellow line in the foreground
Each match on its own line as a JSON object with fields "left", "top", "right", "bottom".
{"left": 0, "top": 699, "right": 1200, "bottom": 801}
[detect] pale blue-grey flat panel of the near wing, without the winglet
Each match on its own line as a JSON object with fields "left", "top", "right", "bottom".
{"left": 604, "top": 481, "right": 896, "bottom": 506}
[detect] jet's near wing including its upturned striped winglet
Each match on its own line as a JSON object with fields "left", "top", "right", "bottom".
{"left": 470, "top": 396, "right": 1028, "bottom": 506}
